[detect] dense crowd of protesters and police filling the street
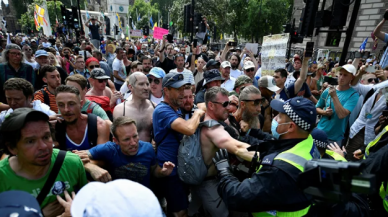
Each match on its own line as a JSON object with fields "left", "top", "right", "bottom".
{"left": 0, "top": 12, "right": 388, "bottom": 216}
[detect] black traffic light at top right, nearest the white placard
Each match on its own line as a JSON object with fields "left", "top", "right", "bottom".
{"left": 299, "top": 0, "right": 319, "bottom": 36}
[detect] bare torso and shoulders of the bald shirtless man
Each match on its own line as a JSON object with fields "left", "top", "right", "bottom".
{"left": 113, "top": 100, "right": 154, "bottom": 142}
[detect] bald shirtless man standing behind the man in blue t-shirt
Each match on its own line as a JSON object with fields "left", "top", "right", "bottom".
{"left": 113, "top": 72, "right": 155, "bottom": 142}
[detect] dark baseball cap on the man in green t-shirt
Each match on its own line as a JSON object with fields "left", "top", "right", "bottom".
{"left": 0, "top": 108, "right": 49, "bottom": 132}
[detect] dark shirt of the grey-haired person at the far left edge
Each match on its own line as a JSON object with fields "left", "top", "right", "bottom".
{"left": 0, "top": 63, "right": 36, "bottom": 103}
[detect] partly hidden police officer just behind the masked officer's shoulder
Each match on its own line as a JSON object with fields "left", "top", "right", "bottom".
{"left": 311, "top": 128, "right": 347, "bottom": 162}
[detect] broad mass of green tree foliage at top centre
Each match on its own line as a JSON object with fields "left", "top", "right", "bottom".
{"left": 171, "top": 0, "right": 293, "bottom": 42}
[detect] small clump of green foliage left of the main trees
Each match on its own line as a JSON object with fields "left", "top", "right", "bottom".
{"left": 128, "top": 0, "right": 159, "bottom": 29}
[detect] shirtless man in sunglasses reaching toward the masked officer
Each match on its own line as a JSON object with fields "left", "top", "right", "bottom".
{"left": 189, "top": 87, "right": 254, "bottom": 216}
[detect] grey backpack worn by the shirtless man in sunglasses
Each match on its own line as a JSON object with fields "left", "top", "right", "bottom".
{"left": 177, "top": 120, "right": 220, "bottom": 185}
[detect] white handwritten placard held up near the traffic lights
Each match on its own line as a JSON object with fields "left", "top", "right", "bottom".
{"left": 261, "top": 33, "right": 289, "bottom": 76}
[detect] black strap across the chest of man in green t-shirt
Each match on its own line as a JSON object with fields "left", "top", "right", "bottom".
{"left": 36, "top": 150, "right": 66, "bottom": 205}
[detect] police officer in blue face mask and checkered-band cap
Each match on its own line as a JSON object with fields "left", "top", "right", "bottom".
{"left": 213, "top": 98, "right": 319, "bottom": 216}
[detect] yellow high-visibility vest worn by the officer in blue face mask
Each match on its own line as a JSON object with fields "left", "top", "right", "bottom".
{"left": 252, "top": 135, "right": 314, "bottom": 217}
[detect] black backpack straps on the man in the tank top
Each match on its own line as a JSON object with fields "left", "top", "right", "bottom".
{"left": 55, "top": 114, "right": 98, "bottom": 150}
